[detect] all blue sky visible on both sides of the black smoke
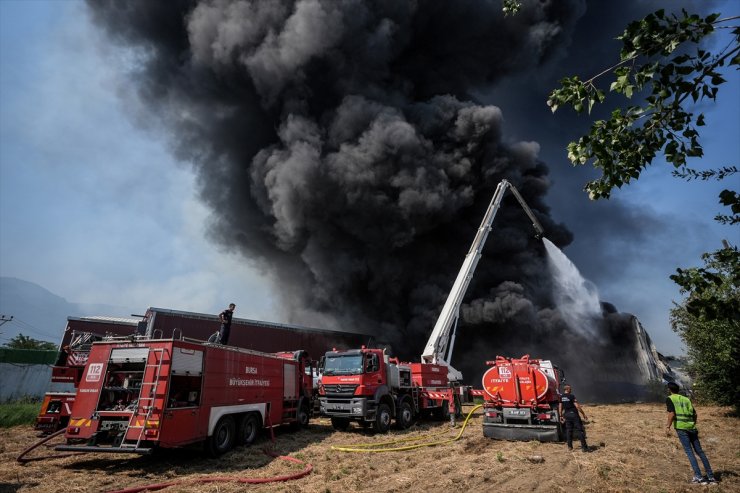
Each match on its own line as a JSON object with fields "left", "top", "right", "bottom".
{"left": 0, "top": 0, "right": 740, "bottom": 354}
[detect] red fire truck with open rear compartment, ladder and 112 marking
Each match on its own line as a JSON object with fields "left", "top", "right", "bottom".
{"left": 56, "top": 336, "right": 312, "bottom": 456}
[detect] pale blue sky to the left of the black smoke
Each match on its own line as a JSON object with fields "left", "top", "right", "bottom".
{"left": 0, "top": 0, "right": 275, "bottom": 319}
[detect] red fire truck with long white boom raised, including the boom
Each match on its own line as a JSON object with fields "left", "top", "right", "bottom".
{"left": 319, "top": 180, "right": 544, "bottom": 432}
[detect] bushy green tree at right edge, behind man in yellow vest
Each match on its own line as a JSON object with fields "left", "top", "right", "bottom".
{"left": 671, "top": 247, "right": 740, "bottom": 412}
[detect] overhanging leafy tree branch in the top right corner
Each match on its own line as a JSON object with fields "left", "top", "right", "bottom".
{"left": 547, "top": 10, "right": 740, "bottom": 203}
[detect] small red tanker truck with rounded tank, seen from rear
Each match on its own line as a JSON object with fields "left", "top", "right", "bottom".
{"left": 483, "top": 355, "right": 564, "bottom": 442}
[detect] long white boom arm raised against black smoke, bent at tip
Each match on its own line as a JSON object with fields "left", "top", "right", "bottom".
{"left": 421, "top": 180, "right": 544, "bottom": 382}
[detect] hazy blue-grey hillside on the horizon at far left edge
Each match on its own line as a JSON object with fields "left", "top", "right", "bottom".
{"left": 0, "top": 277, "right": 131, "bottom": 345}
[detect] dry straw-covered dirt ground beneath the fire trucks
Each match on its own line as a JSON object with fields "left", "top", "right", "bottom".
{"left": 0, "top": 404, "right": 740, "bottom": 493}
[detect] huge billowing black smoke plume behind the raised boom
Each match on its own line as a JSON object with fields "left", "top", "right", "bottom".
{"left": 84, "top": 0, "right": 684, "bottom": 398}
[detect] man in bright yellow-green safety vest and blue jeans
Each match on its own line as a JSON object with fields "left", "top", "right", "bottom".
{"left": 665, "top": 382, "right": 717, "bottom": 485}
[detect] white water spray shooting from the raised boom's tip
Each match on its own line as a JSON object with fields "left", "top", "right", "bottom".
{"left": 542, "top": 238, "right": 602, "bottom": 338}
